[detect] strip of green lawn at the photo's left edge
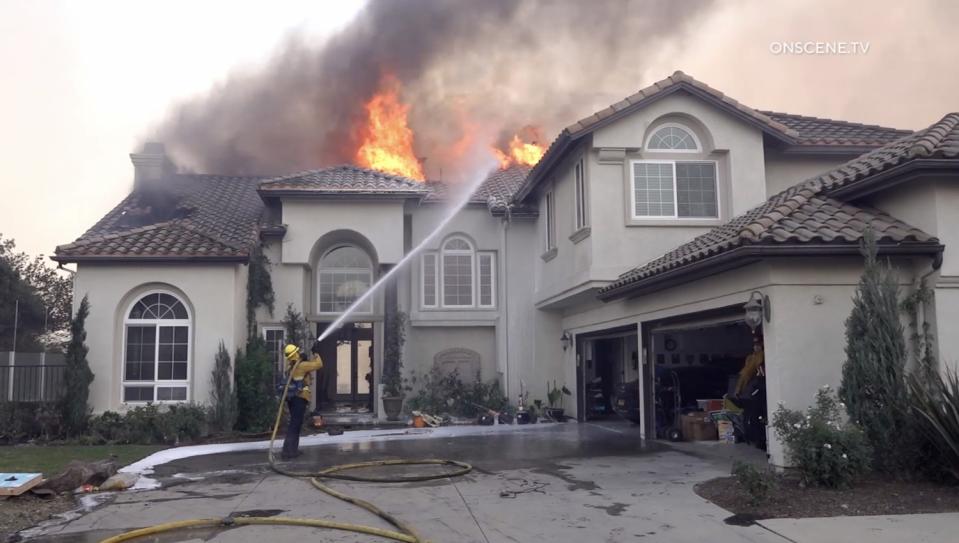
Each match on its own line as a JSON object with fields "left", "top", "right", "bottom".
{"left": 0, "top": 445, "right": 166, "bottom": 477}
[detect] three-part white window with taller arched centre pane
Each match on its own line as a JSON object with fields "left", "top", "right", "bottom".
{"left": 420, "top": 236, "right": 495, "bottom": 309}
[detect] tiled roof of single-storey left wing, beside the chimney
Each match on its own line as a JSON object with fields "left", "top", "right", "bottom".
{"left": 52, "top": 174, "right": 263, "bottom": 262}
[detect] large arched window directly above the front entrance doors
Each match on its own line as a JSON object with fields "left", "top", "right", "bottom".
{"left": 316, "top": 245, "right": 373, "bottom": 313}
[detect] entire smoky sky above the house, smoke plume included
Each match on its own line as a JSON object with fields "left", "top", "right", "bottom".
{"left": 0, "top": 0, "right": 959, "bottom": 260}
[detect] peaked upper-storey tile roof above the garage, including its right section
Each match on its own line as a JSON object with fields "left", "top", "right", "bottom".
{"left": 515, "top": 71, "right": 909, "bottom": 200}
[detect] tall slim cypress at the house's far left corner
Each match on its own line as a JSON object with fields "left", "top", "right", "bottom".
{"left": 59, "top": 296, "right": 93, "bottom": 437}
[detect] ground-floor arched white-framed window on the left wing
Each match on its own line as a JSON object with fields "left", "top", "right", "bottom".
{"left": 123, "top": 292, "right": 192, "bottom": 403}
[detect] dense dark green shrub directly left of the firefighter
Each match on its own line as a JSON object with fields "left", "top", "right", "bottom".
{"left": 234, "top": 336, "right": 276, "bottom": 432}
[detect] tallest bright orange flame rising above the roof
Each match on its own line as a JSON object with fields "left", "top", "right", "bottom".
{"left": 356, "top": 75, "right": 426, "bottom": 181}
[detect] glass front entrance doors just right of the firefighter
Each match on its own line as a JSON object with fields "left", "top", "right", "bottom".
{"left": 317, "top": 322, "right": 373, "bottom": 412}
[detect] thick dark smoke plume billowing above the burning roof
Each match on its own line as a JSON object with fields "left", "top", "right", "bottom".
{"left": 158, "top": 0, "right": 708, "bottom": 183}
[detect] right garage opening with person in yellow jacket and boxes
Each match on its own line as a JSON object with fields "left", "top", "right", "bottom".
{"left": 646, "top": 308, "right": 767, "bottom": 450}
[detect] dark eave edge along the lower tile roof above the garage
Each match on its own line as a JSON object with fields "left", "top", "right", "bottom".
{"left": 597, "top": 241, "right": 945, "bottom": 302}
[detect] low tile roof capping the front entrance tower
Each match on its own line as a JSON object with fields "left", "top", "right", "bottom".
{"left": 260, "top": 165, "right": 429, "bottom": 196}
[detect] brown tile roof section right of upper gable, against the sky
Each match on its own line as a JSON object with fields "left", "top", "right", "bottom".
{"left": 759, "top": 111, "right": 912, "bottom": 147}
